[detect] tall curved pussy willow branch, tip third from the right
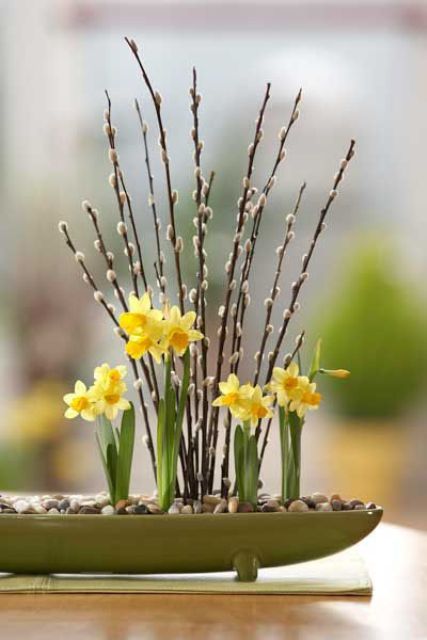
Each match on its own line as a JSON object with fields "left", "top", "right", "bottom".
{"left": 231, "top": 89, "right": 302, "bottom": 373}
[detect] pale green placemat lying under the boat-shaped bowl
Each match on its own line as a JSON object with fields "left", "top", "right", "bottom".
{"left": 0, "top": 549, "right": 372, "bottom": 596}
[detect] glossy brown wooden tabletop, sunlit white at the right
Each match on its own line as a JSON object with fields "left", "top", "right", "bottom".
{"left": 0, "top": 524, "right": 427, "bottom": 640}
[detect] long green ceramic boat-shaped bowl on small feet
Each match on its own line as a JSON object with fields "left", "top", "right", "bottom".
{"left": 0, "top": 509, "right": 382, "bottom": 581}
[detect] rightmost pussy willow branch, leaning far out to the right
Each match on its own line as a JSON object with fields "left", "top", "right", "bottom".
{"left": 266, "top": 140, "right": 355, "bottom": 383}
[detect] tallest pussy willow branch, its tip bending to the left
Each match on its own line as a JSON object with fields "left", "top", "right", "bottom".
{"left": 125, "top": 38, "right": 186, "bottom": 313}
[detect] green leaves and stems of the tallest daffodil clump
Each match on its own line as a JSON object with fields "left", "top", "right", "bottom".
{"left": 157, "top": 347, "right": 190, "bottom": 511}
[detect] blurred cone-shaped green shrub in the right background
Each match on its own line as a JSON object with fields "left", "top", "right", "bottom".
{"left": 316, "top": 238, "right": 427, "bottom": 418}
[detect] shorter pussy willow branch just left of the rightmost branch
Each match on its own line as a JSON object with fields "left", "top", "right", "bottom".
{"left": 253, "top": 182, "right": 306, "bottom": 385}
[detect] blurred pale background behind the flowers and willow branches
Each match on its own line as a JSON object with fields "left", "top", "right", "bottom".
{"left": 0, "top": 0, "right": 427, "bottom": 528}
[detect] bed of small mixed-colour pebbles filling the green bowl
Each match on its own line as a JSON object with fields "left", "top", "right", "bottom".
{"left": 0, "top": 493, "right": 377, "bottom": 516}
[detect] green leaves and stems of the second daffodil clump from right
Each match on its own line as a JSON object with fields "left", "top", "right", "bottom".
{"left": 234, "top": 420, "right": 259, "bottom": 509}
